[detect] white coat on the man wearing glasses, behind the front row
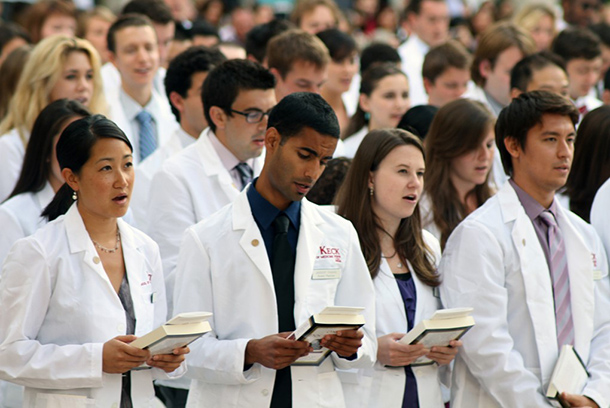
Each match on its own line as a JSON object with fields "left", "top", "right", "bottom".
{"left": 146, "top": 128, "right": 263, "bottom": 316}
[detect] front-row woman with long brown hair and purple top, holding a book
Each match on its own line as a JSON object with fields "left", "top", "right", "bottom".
{"left": 337, "top": 129, "right": 461, "bottom": 408}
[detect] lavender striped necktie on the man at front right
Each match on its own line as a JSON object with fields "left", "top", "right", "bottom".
{"left": 540, "top": 210, "right": 574, "bottom": 348}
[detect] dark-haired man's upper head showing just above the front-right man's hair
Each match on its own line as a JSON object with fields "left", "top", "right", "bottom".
{"left": 510, "top": 51, "right": 569, "bottom": 98}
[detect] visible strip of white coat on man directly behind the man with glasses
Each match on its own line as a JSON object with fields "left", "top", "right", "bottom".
{"left": 129, "top": 127, "right": 196, "bottom": 231}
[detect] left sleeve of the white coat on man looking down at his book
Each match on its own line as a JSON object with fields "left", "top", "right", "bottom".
{"left": 174, "top": 228, "right": 261, "bottom": 384}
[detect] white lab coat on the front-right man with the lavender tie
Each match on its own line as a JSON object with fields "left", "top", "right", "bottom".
{"left": 440, "top": 183, "right": 610, "bottom": 408}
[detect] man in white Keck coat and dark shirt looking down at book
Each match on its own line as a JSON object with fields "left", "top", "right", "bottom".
{"left": 174, "top": 92, "right": 376, "bottom": 408}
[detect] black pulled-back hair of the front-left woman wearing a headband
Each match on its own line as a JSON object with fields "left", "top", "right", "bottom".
{"left": 41, "top": 115, "right": 133, "bottom": 221}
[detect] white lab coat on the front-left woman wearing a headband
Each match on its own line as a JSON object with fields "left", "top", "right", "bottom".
{"left": 0, "top": 205, "right": 184, "bottom": 407}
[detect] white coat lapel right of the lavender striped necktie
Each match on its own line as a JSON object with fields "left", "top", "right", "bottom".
{"left": 557, "top": 206, "right": 595, "bottom": 361}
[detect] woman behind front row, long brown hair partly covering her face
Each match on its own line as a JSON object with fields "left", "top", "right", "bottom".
{"left": 420, "top": 99, "right": 495, "bottom": 248}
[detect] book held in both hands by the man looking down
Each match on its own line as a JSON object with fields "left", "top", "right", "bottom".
{"left": 288, "top": 306, "right": 364, "bottom": 365}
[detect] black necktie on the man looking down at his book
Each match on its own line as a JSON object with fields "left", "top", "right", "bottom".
{"left": 271, "top": 213, "right": 295, "bottom": 408}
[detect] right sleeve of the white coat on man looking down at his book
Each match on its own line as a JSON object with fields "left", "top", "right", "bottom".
{"left": 331, "top": 225, "right": 377, "bottom": 369}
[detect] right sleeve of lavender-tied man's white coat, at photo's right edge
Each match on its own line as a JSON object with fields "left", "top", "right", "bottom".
{"left": 582, "top": 233, "right": 610, "bottom": 407}
